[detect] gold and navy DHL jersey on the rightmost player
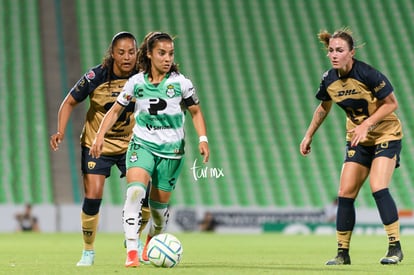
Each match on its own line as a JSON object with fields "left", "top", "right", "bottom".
{"left": 316, "top": 60, "right": 403, "bottom": 146}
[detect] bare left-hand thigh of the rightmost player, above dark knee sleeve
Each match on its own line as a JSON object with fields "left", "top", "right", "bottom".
{"left": 338, "top": 162, "right": 369, "bottom": 198}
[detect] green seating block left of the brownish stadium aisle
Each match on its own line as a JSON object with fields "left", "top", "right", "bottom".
{"left": 0, "top": 1, "right": 53, "bottom": 203}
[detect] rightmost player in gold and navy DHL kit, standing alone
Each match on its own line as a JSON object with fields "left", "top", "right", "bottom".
{"left": 300, "top": 28, "right": 403, "bottom": 265}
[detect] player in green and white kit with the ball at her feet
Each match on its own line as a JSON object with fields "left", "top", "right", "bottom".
{"left": 90, "top": 32, "right": 210, "bottom": 267}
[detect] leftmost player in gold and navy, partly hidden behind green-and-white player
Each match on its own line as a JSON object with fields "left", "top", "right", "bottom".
{"left": 50, "top": 32, "right": 150, "bottom": 266}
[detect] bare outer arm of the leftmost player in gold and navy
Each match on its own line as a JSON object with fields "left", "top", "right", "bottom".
{"left": 50, "top": 93, "right": 78, "bottom": 151}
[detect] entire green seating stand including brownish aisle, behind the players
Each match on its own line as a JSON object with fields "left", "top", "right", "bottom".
{"left": 0, "top": 0, "right": 414, "bottom": 233}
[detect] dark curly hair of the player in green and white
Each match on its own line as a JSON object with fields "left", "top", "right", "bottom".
{"left": 138, "top": 32, "right": 178, "bottom": 76}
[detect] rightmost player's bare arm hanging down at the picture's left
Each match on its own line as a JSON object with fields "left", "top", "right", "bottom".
{"left": 300, "top": 100, "right": 332, "bottom": 156}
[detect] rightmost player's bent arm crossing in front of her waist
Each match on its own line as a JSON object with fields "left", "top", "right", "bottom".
{"left": 349, "top": 92, "right": 398, "bottom": 146}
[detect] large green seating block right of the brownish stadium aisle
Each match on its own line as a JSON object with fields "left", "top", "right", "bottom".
{"left": 68, "top": 0, "right": 414, "bottom": 208}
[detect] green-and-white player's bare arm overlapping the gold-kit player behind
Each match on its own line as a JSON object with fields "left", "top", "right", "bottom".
{"left": 89, "top": 102, "right": 125, "bottom": 158}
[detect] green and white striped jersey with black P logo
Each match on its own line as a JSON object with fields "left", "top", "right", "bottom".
{"left": 117, "top": 72, "right": 198, "bottom": 158}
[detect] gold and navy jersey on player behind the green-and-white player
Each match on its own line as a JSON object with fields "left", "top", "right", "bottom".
{"left": 70, "top": 65, "right": 136, "bottom": 155}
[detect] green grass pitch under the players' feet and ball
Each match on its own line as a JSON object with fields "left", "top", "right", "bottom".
{"left": 0, "top": 233, "right": 414, "bottom": 275}
